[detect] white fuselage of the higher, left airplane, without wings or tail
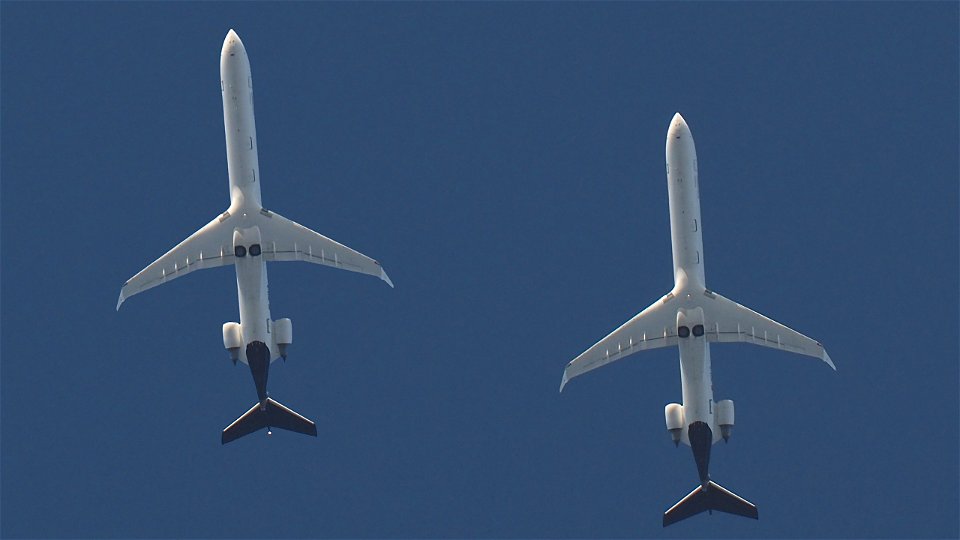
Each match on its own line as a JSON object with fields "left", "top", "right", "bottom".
{"left": 220, "top": 30, "right": 279, "bottom": 363}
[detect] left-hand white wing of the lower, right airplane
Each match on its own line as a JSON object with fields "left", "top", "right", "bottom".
{"left": 560, "top": 293, "right": 677, "bottom": 392}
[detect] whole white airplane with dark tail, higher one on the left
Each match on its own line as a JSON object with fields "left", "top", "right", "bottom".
{"left": 117, "top": 30, "right": 393, "bottom": 444}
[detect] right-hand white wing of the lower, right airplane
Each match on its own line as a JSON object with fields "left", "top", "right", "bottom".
{"left": 703, "top": 291, "right": 837, "bottom": 371}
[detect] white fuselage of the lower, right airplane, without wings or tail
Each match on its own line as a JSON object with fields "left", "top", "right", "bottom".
{"left": 666, "top": 113, "right": 720, "bottom": 444}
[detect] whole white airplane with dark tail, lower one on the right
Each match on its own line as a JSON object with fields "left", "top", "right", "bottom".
{"left": 560, "top": 113, "right": 837, "bottom": 527}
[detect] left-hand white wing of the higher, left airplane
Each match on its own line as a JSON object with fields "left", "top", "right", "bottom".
{"left": 117, "top": 212, "right": 237, "bottom": 311}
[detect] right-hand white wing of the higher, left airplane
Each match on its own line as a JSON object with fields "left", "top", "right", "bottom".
{"left": 257, "top": 210, "right": 393, "bottom": 287}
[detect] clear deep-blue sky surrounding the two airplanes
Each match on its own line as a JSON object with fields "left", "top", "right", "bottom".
{"left": 0, "top": 2, "right": 960, "bottom": 538}
